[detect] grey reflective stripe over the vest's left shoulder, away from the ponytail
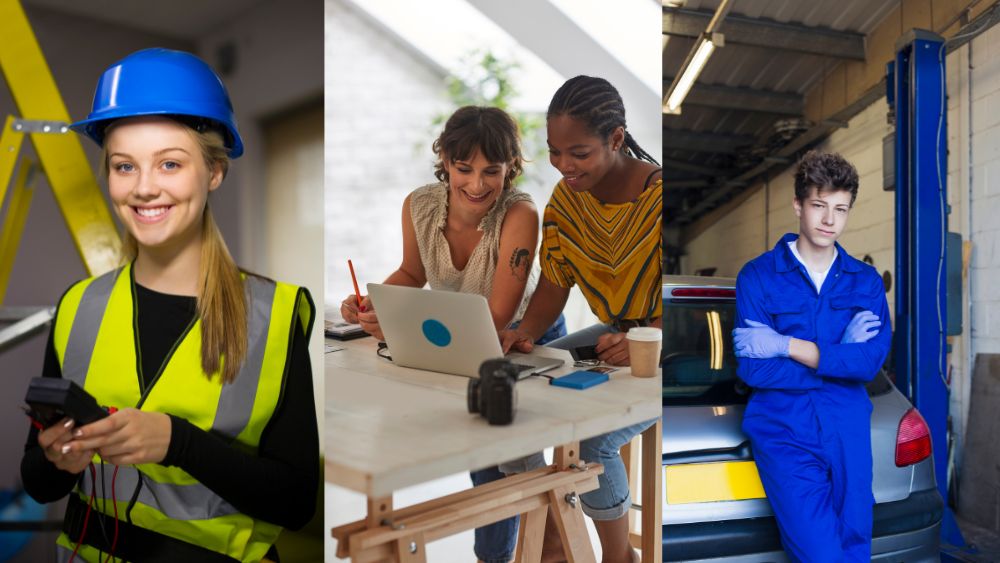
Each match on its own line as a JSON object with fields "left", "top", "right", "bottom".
{"left": 62, "top": 268, "right": 122, "bottom": 387}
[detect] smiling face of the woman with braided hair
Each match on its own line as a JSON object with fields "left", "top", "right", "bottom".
{"left": 546, "top": 114, "right": 625, "bottom": 192}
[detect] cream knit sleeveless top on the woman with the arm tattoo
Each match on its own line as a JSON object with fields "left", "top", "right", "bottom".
{"left": 410, "top": 182, "right": 538, "bottom": 321}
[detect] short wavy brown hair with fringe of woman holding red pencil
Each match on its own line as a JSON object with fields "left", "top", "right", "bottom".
{"left": 431, "top": 106, "right": 524, "bottom": 188}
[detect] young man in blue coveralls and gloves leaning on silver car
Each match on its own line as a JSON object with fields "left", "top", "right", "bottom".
{"left": 733, "top": 151, "right": 892, "bottom": 563}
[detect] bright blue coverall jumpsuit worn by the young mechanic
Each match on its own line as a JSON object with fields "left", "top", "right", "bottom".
{"left": 736, "top": 234, "right": 892, "bottom": 563}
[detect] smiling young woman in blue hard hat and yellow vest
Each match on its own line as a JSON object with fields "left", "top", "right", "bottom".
{"left": 21, "top": 49, "right": 319, "bottom": 562}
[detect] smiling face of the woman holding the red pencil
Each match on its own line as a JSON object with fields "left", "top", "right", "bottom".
{"left": 442, "top": 151, "right": 509, "bottom": 214}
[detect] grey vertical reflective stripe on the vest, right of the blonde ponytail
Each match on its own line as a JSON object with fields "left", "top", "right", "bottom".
{"left": 212, "top": 276, "right": 281, "bottom": 438}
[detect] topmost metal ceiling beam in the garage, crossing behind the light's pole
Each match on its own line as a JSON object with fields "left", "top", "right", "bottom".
{"left": 663, "top": 8, "right": 865, "bottom": 61}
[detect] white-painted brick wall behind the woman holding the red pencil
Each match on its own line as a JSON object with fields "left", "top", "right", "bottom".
{"left": 324, "top": 0, "right": 445, "bottom": 303}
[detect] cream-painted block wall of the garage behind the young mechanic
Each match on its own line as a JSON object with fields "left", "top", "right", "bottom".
{"left": 681, "top": 27, "right": 1000, "bottom": 476}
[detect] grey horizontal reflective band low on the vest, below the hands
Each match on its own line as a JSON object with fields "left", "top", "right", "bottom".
{"left": 80, "top": 466, "right": 239, "bottom": 520}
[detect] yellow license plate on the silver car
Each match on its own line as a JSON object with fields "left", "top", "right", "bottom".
{"left": 663, "top": 461, "right": 766, "bottom": 504}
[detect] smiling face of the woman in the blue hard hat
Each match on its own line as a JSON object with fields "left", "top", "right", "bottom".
{"left": 105, "top": 117, "right": 223, "bottom": 252}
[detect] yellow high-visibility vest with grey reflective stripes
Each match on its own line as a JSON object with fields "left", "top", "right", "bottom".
{"left": 53, "top": 265, "right": 314, "bottom": 561}
